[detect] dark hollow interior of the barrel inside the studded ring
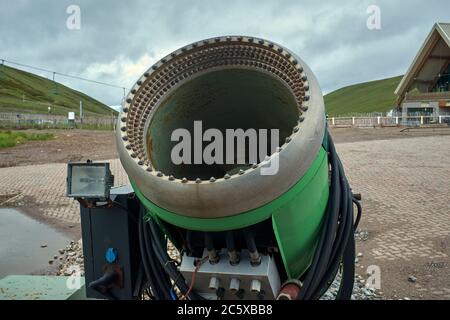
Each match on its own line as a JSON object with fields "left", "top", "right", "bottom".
{"left": 146, "top": 68, "right": 298, "bottom": 180}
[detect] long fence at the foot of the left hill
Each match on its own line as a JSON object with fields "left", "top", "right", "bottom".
{"left": 0, "top": 113, "right": 117, "bottom": 130}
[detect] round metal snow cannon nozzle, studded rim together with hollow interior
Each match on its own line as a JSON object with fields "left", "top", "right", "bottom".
{"left": 116, "top": 36, "right": 326, "bottom": 219}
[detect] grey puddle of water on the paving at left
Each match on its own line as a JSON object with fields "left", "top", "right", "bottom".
{"left": 0, "top": 208, "right": 70, "bottom": 278}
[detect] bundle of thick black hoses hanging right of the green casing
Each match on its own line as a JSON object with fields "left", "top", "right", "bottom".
{"left": 298, "top": 131, "right": 362, "bottom": 300}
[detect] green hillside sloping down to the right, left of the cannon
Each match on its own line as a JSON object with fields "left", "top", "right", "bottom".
{"left": 0, "top": 65, "right": 115, "bottom": 115}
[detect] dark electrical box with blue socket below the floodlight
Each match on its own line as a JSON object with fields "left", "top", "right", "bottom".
{"left": 81, "top": 186, "right": 141, "bottom": 300}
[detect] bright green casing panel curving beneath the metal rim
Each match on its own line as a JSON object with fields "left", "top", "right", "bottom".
{"left": 132, "top": 147, "right": 329, "bottom": 278}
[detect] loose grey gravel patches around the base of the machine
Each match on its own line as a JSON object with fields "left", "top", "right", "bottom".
{"left": 52, "top": 232, "right": 382, "bottom": 300}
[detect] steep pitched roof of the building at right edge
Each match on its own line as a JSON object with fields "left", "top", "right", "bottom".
{"left": 395, "top": 23, "right": 450, "bottom": 104}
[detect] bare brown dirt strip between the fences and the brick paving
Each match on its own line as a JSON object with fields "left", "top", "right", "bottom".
{"left": 0, "top": 127, "right": 450, "bottom": 168}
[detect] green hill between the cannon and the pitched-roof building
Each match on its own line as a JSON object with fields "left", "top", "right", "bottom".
{"left": 325, "top": 76, "right": 402, "bottom": 117}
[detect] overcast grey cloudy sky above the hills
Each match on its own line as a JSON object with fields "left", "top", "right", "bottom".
{"left": 0, "top": 0, "right": 450, "bottom": 105}
